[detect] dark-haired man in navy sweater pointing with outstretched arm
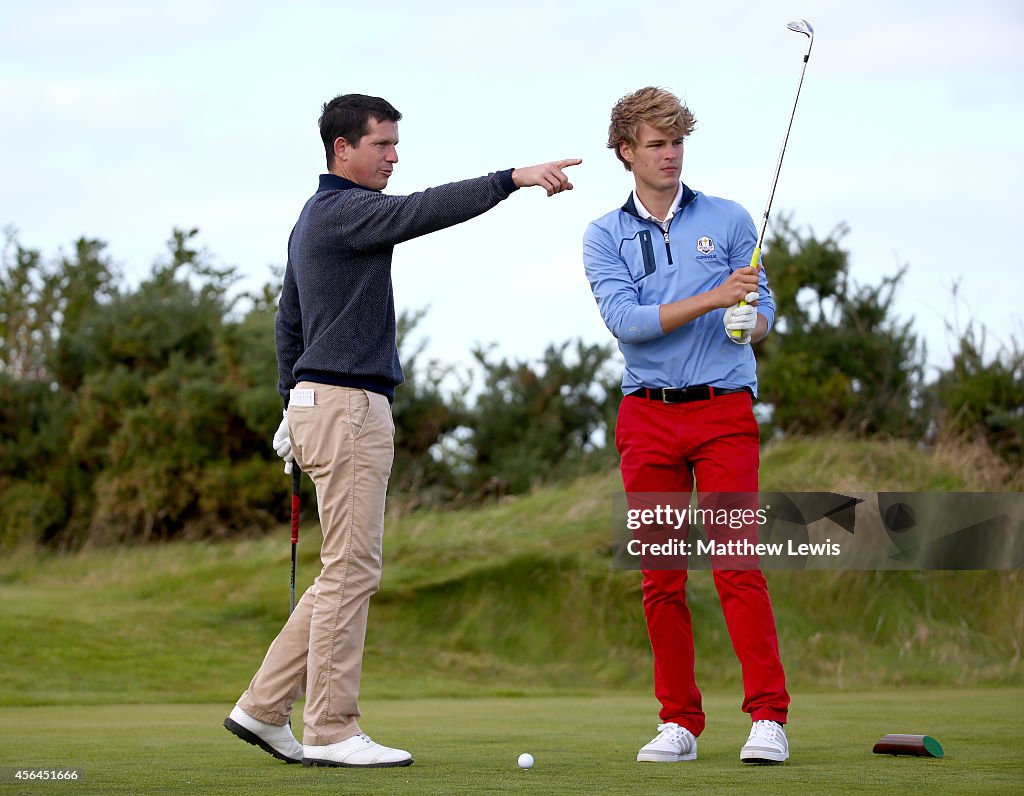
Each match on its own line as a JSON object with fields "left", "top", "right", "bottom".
{"left": 224, "top": 94, "right": 581, "bottom": 767}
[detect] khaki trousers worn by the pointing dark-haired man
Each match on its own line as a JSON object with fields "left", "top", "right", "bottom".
{"left": 238, "top": 382, "right": 394, "bottom": 746}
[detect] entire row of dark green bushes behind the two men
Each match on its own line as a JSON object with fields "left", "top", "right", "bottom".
{"left": 0, "top": 222, "right": 1024, "bottom": 549}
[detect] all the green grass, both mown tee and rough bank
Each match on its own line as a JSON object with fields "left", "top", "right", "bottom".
{"left": 0, "top": 441, "right": 1024, "bottom": 794}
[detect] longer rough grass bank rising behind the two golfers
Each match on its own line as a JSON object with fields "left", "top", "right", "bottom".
{"left": 0, "top": 439, "right": 1024, "bottom": 705}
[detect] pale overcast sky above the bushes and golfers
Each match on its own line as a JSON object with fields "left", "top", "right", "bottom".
{"left": 0, "top": 0, "right": 1024, "bottom": 379}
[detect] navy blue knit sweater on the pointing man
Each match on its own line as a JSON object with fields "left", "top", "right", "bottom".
{"left": 275, "top": 169, "right": 516, "bottom": 407}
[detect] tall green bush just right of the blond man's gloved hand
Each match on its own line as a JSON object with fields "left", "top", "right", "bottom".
{"left": 756, "top": 219, "right": 925, "bottom": 438}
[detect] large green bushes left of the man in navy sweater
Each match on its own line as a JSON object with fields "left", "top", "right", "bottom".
{"left": 0, "top": 229, "right": 289, "bottom": 548}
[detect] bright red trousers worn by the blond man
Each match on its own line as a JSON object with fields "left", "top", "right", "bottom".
{"left": 615, "top": 392, "right": 790, "bottom": 736}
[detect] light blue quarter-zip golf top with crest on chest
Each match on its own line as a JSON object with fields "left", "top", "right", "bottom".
{"left": 583, "top": 182, "right": 775, "bottom": 395}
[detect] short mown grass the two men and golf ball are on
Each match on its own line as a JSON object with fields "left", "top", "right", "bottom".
{"left": 0, "top": 688, "right": 1024, "bottom": 794}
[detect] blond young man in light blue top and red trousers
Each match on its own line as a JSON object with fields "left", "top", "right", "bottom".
{"left": 584, "top": 87, "right": 790, "bottom": 763}
